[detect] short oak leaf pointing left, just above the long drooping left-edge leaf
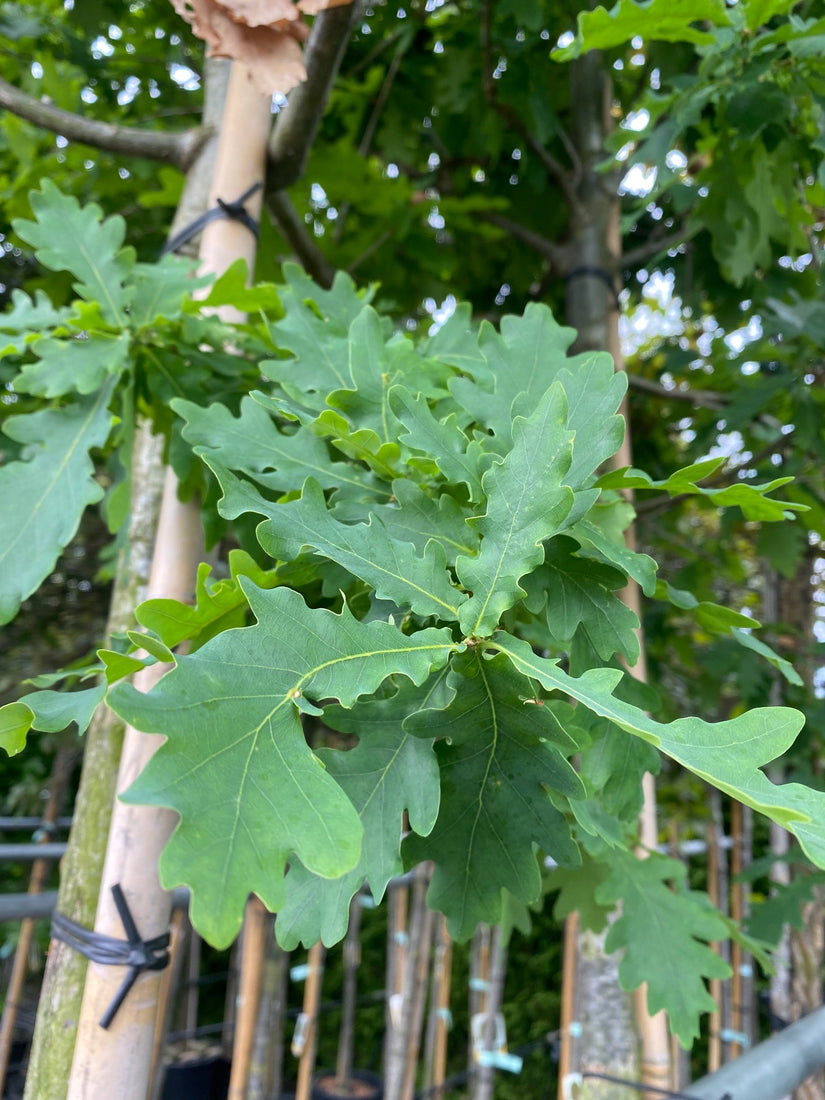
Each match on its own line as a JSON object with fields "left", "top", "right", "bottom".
{"left": 14, "top": 332, "right": 130, "bottom": 397}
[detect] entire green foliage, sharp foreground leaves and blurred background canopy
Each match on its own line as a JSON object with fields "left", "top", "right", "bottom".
{"left": 0, "top": 0, "right": 825, "bottom": 1056}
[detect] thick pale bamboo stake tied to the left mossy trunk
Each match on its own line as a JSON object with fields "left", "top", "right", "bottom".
{"left": 68, "top": 65, "right": 271, "bottom": 1100}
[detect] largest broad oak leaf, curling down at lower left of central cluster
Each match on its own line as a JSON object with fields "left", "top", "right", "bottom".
{"left": 109, "top": 579, "right": 457, "bottom": 946}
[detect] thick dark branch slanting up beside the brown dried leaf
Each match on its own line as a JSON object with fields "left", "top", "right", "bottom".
{"left": 267, "top": 0, "right": 361, "bottom": 191}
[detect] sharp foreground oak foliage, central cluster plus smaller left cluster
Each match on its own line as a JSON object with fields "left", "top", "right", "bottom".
{"left": 0, "top": 186, "right": 825, "bottom": 1042}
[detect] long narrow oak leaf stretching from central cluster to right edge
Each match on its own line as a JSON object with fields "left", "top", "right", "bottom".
{"left": 491, "top": 633, "right": 825, "bottom": 867}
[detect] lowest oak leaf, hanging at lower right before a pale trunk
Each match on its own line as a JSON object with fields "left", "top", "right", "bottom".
{"left": 596, "top": 851, "right": 730, "bottom": 1049}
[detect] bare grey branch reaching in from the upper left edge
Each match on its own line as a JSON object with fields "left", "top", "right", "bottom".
{"left": 0, "top": 77, "right": 209, "bottom": 171}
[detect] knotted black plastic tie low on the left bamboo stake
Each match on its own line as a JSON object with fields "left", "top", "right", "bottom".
{"left": 52, "top": 882, "right": 169, "bottom": 1029}
